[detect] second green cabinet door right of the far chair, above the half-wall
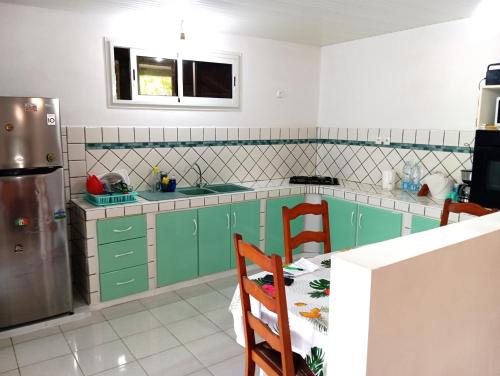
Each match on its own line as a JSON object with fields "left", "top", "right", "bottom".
{"left": 357, "top": 205, "right": 403, "bottom": 246}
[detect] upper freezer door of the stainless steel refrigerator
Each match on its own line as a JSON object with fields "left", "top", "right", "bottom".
{"left": 0, "top": 97, "right": 63, "bottom": 170}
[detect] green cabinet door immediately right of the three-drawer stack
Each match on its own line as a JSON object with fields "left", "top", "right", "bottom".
{"left": 156, "top": 210, "right": 199, "bottom": 286}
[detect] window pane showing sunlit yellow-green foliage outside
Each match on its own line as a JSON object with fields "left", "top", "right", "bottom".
{"left": 137, "top": 56, "right": 177, "bottom": 97}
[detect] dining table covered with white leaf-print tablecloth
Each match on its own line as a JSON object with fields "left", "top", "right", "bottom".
{"left": 229, "top": 253, "right": 332, "bottom": 376}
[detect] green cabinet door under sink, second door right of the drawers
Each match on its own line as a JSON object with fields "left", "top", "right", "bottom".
{"left": 198, "top": 205, "right": 231, "bottom": 276}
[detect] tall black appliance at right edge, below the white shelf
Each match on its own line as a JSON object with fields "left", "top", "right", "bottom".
{"left": 470, "top": 130, "right": 500, "bottom": 209}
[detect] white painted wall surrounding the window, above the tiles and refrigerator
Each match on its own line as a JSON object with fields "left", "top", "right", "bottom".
{"left": 0, "top": 3, "right": 320, "bottom": 127}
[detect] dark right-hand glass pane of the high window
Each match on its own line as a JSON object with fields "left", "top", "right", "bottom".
{"left": 182, "top": 60, "right": 233, "bottom": 98}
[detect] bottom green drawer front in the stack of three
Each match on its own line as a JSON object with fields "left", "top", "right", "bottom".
{"left": 100, "top": 264, "right": 148, "bottom": 302}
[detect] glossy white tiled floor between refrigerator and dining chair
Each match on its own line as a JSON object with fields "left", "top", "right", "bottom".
{"left": 0, "top": 277, "right": 250, "bottom": 376}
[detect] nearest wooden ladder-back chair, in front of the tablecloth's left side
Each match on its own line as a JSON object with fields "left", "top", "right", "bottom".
{"left": 234, "top": 234, "right": 314, "bottom": 376}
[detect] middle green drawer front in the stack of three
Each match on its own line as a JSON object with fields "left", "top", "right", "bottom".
{"left": 99, "top": 238, "right": 148, "bottom": 274}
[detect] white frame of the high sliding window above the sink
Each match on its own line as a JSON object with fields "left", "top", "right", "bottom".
{"left": 105, "top": 39, "right": 241, "bottom": 109}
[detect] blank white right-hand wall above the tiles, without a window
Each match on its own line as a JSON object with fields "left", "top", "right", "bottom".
{"left": 318, "top": 20, "right": 500, "bottom": 130}
